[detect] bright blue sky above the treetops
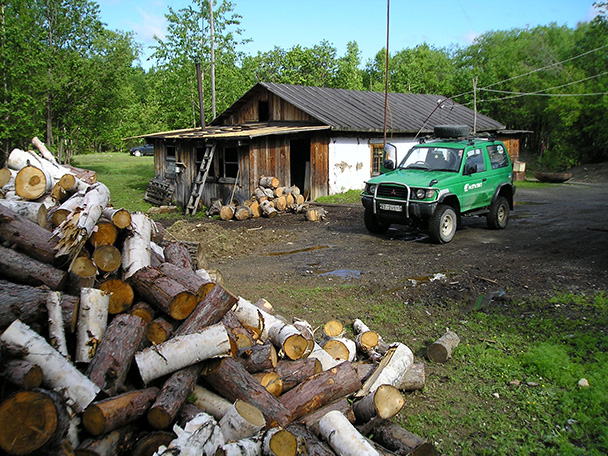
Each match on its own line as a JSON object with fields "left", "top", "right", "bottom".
{"left": 98, "top": 0, "right": 594, "bottom": 68}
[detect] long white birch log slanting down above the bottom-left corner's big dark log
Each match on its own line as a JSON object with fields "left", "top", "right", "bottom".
{"left": 0, "top": 320, "right": 99, "bottom": 413}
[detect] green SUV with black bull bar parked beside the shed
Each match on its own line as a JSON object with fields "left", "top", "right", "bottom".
{"left": 361, "top": 125, "right": 515, "bottom": 244}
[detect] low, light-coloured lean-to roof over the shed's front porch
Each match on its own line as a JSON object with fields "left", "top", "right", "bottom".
{"left": 133, "top": 122, "right": 331, "bottom": 139}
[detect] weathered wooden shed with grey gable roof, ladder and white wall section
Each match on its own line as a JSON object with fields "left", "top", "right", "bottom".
{"left": 142, "top": 82, "right": 505, "bottom": 207}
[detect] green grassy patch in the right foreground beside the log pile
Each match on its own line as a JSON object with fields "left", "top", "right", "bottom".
{"left": 260, "top": 284, "right": 608, "bottom": 456}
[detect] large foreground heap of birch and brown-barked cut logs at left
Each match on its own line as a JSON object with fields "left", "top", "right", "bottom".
{"left": 0, "top": 143, "right": 446, "bottom": 456}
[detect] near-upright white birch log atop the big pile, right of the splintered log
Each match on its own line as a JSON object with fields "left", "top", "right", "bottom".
{"left": 122, "top": 212, "right": 152, "bottom": 279}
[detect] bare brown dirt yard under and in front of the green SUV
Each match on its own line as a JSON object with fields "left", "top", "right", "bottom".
{"left": 169, "top": 163, "right": 608, "bottom": 313}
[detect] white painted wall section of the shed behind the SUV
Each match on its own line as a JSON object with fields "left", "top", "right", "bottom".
{"left": 329, "top": 137, "right": 417, "bottom": 195}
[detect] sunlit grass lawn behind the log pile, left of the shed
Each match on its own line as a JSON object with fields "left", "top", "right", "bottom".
{"left": 72, "top": 153, "right": 154, "bottom": 212}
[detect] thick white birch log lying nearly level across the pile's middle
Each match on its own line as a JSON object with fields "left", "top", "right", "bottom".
{"left": 135, "top": 324, "right": 236, "bottom": 384}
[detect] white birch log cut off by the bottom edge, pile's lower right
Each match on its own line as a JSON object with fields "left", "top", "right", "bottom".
{"left": 319, "top": 411, "right": 380, "bottom": 456}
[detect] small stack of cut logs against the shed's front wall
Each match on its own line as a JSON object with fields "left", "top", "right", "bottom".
{"left": 207, "top": 176, "right": 326, "bottom": 222}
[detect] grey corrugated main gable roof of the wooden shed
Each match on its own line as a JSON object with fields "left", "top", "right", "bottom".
{"left": 212, "top": 82, "right": 505, "bottom": 133}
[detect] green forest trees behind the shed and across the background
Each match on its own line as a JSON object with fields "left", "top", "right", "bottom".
{"left": 0, "top": 0, "right": 608, "bottom": 170}
